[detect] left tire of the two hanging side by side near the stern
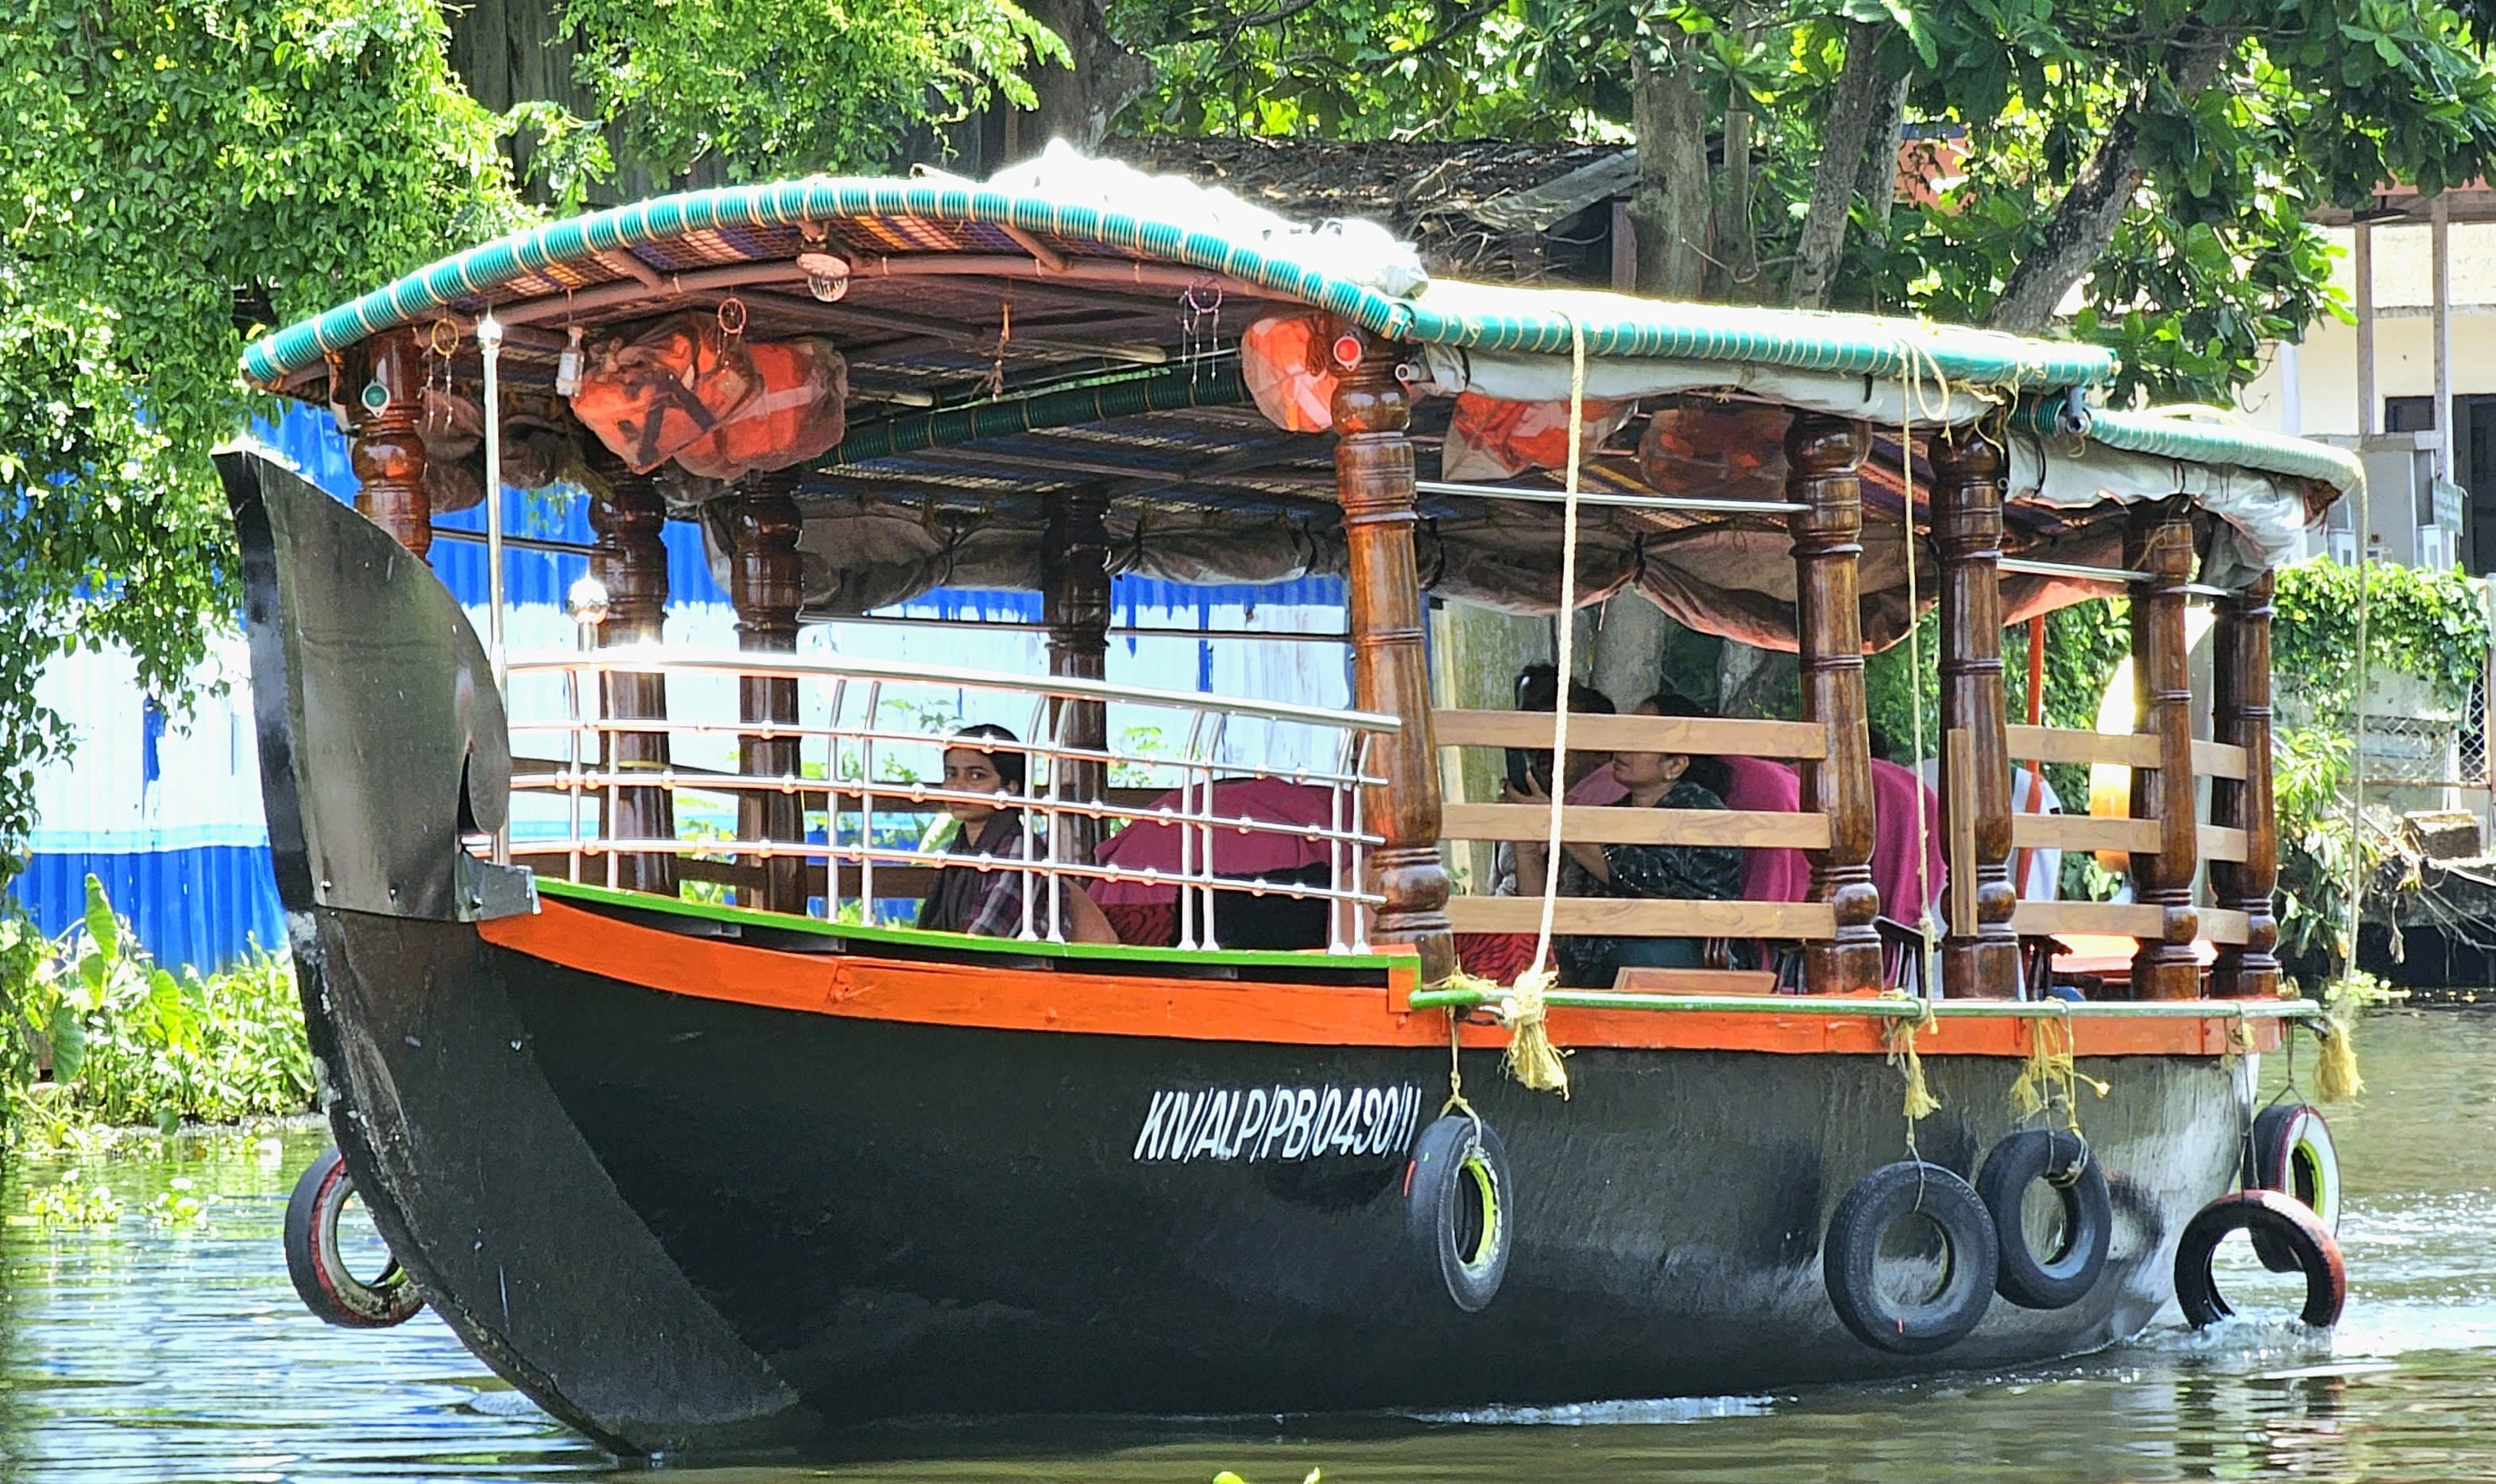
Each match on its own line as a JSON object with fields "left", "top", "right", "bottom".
{"left": 1820, "top": 1160, "right": 2002, "bottom": 1355}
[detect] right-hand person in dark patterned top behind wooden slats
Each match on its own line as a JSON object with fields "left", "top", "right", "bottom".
{"left": 1518, "top": 698, "right": 1742, "bottom": 987}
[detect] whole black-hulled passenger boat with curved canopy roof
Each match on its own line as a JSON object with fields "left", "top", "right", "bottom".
{"left": 225, "top": 157, "right": 2359, "bottom": 1451}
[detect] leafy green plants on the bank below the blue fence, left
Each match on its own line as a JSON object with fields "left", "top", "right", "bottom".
{"left": 0, "top": 875, "right": 315, "bottom": 1138}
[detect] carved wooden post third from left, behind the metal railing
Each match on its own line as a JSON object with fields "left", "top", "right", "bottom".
{"left": 729, "top": 474, "right": 803, "bottom": 913}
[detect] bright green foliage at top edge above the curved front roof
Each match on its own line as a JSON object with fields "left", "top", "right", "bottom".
{"left": 562, "top": 0, "right": 1068, "bottom": 180}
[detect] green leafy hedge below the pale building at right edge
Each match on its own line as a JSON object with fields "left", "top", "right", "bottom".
{"left": 2271, "top": 556, "right": 2491, "bottom": 728}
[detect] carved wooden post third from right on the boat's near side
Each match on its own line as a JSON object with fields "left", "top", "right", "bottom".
{"left": 1932, "top": 429, "right": 2019, "bottom": 998}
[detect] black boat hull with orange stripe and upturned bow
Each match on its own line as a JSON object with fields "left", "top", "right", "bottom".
{"left": 227, "top": 459, "right": 2246, "bottom": 1451}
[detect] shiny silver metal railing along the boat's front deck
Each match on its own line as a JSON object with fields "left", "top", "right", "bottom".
{"left": 507, "top": 646, "right": 1400, "bottom": 950}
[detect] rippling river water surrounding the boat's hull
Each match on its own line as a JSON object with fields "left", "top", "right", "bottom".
{"left": 0, "top": 1010, "right": 2496, "bottom": 1484}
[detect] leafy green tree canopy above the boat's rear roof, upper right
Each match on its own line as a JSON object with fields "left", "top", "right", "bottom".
{"left": 1111, "top": 0, "right": 2496, "bottom": 401}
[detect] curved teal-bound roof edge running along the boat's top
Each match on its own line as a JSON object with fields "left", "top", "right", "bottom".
{"left": 242, "top": 177, "right": 2361, "bottom": 491}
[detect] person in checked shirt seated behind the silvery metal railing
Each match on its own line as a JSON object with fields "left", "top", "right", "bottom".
{"left": 919, "top": 726, "right": 1118, "bottom": 943}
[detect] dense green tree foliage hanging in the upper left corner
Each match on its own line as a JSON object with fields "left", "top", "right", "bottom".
{"left": 0, "top": 0, "right": 536, "bottom": 848}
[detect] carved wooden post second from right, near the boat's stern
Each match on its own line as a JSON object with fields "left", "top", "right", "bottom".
{"left": 2124, "top": 506, "right": 2201, "bottom": 1000}
